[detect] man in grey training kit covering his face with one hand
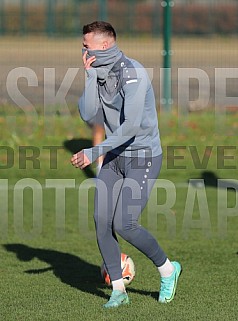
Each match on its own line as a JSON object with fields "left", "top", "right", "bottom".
{"left": 71, "top": 21, "right": 181, "bottom": 308}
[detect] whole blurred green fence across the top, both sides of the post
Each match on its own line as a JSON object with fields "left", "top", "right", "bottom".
{"left": 0, "top": 0, "right": 238, "bottom": 36}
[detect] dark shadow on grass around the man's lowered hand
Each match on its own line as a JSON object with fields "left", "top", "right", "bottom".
{"left": 63, "top": 138, "right": 95, "bottom": 178}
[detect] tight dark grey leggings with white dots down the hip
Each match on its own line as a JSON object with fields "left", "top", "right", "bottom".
{"left": 94, "top": 153, "right": 167, "bottom": 281}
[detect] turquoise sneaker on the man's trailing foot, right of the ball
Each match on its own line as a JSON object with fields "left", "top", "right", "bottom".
{"left": 158, "top": 262, "right": 182, "bottom": 303}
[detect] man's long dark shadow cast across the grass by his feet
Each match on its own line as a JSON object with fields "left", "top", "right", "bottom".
{"left": 3, "top": 244, "right": 158, "bottom": 299}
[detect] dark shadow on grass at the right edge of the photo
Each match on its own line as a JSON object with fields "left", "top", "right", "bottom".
{"left": 190, "top": 171, "right": 238, "bottom": 192}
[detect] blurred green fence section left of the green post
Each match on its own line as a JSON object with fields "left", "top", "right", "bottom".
{"left": 0, "top": 0, "right": 162, "bottom": 36}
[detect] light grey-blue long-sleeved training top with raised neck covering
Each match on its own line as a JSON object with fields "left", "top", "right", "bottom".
{"left": 79, "top": 45, "right": 162, "bottom": 162}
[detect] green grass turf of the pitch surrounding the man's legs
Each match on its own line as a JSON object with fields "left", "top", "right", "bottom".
{"left": 0, "top": 113, "right": 238, "bottom": 321}
